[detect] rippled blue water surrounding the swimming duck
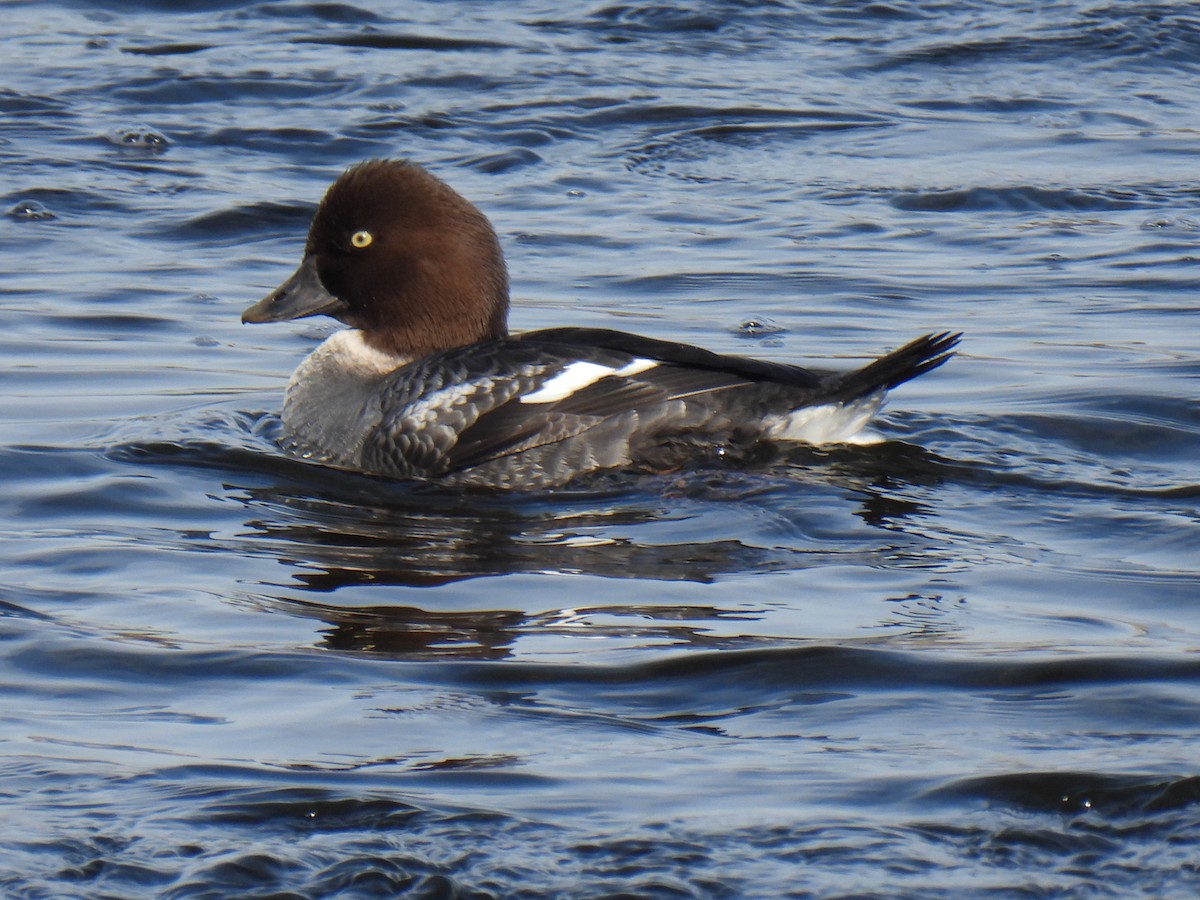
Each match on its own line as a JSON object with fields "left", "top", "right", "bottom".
{"left": 0, "top": 0, "right": 1200, "bottom": 898}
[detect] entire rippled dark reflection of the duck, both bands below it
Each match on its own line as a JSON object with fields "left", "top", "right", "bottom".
{"left": 227, "top": 445, "right": 955, "bottom": 659}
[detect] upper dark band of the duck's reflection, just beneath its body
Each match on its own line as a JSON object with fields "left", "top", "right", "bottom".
{"left": 231, "top": 468, "right": 816, "bottom": 593}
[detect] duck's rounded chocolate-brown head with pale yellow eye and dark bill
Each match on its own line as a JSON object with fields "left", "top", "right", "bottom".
{"left": 241, "top": 160, "right": 509, "bottom": 358}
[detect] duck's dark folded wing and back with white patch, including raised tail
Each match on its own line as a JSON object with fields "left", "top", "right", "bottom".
{"left": 362, "top": 328, "right": 959, "bottom": 476}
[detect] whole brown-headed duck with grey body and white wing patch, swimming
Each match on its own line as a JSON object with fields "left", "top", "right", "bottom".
{"left": 241, "top": 160, "right": 959, "bottom": 488}
